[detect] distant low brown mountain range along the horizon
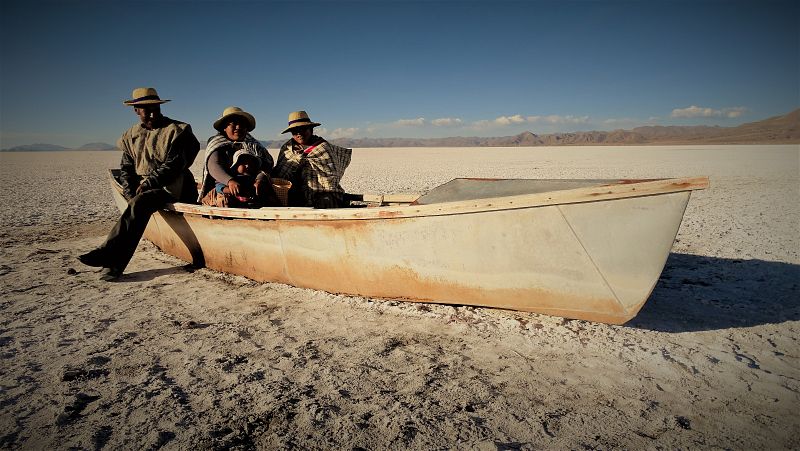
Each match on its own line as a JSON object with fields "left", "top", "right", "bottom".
{"left": 0, "top": 109, "right": 800, "bottom": 152}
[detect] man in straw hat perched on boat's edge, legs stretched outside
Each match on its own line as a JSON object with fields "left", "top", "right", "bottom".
{"left": 78, "top": 88, "right": 200, "bottom": 281}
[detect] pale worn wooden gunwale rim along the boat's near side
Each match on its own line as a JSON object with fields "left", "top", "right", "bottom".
{"left": 108, "top": 169, "right": 709, "bottom": 221}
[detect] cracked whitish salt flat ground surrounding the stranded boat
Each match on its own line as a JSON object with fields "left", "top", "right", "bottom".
{"left": 0, "top": 145, "right": 800, "bottom": 449}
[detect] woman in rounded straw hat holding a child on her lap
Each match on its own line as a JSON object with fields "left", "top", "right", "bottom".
{"left": 197, "top": 106, "right": 278, "bottom": 205}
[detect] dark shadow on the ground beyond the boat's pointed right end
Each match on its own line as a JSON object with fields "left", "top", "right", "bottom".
{"left": 626, "top": 253, "right": 800, "bottom": 332}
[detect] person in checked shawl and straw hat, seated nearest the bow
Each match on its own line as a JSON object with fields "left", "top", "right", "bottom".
{"left": 272, "top": 111, "right": 352, "bottom": 208}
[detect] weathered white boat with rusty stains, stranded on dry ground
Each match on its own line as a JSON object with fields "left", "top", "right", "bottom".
{"left": 111, "top": 171, "right": 708, "bottom": 324}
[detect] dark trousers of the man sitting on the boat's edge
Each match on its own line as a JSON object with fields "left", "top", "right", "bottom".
{"left": 98, "top": 189, "right": 174, "bottom": 271}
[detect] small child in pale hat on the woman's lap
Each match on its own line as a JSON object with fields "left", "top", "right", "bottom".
{"left": 202, "top": 149, "right": 263, "bottom": 208}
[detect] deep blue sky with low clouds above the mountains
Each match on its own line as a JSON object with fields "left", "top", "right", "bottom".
{"left": 0, "top": 0, "right": 800, "bottom": 148}
